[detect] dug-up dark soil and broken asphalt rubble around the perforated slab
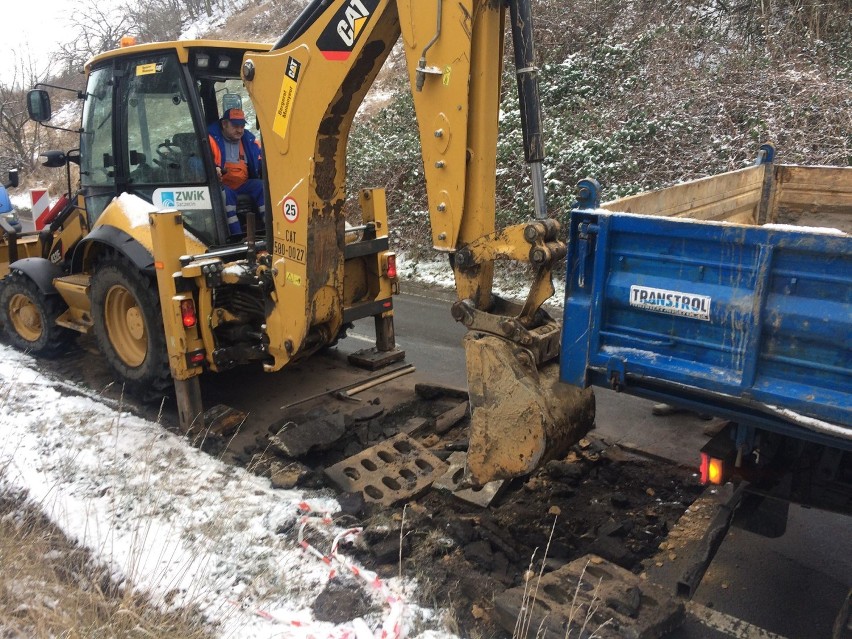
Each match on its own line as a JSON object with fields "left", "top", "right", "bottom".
{"left": 218, "top": 384, "right": 700, "bottom": 637}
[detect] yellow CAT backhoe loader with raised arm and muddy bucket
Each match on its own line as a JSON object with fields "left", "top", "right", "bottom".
{"left": 15, "top": 0, "right": 594, "bottom": 483}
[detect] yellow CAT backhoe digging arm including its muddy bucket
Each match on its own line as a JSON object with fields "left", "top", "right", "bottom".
{"left": 242, "top": 0, "right": 594, "bottom": 484}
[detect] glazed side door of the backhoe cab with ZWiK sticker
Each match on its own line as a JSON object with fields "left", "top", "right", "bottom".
{"left": 83, "top": 51, "right": 226, "bottom": 245}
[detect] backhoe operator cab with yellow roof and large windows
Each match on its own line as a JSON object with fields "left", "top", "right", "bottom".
{"left": 32, "top": 40, "right": 269, "bottom": 247}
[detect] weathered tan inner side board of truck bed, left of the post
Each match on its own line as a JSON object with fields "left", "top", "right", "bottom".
{"left": 601, "top": 165, "right": 765, "bottom": 224}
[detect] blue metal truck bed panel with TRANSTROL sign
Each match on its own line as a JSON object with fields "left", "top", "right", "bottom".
{"left": 560, "top": 209, "right": 852, "bottom": 449}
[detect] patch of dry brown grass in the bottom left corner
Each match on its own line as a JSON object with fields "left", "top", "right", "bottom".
{"left": 0, "top": 484, "right": 211, "bottom": 639}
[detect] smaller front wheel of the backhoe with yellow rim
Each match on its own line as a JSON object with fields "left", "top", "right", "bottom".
{"left": 0, "top": 270, "right": 75, "bottom": 356}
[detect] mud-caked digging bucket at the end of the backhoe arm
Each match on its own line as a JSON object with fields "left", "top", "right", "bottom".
{"left": 464, "top": 332, "right": 595, "bottom": 485}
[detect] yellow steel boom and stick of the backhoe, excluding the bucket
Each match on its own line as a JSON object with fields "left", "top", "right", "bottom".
{"left": 244, "top": 0, "right": 524, "bottom": 369}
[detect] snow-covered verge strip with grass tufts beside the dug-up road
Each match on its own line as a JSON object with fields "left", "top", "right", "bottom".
{"left": 0, "top": 345, "right": 460, "bottom": 639}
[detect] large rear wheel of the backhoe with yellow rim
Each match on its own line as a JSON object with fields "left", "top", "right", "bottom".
{"left": 92, "top": 258, "right": 171, "bottom": 401}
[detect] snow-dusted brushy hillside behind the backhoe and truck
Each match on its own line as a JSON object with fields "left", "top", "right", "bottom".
{"left": 8, "top": 0, "right": 852, "bottom": 255}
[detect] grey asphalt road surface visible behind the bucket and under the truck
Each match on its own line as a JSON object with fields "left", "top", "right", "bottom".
{"left": 339, "top": 284, "right": 852, "bottom": 639}
